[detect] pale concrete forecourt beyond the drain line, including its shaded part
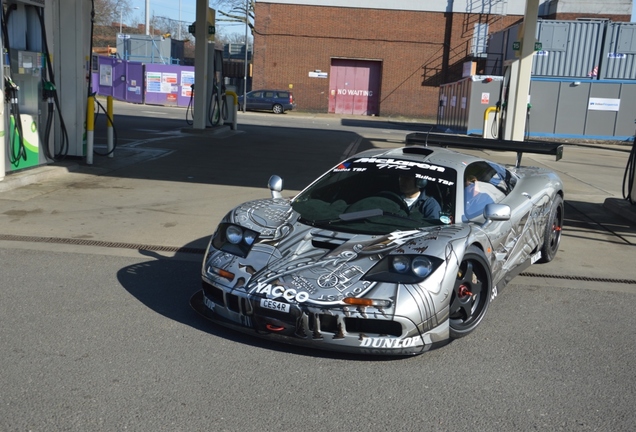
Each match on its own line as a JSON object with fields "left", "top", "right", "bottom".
{"left": 0, "top": 103, "right": 636, "bottom": 283}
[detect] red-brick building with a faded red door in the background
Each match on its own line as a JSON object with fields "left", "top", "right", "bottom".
{"left": 253, "top": 0, "right": 632, "bottom": 118}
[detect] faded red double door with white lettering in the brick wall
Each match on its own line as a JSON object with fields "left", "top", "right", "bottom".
{"left": 329, "top": 59, "right": 382, "bottom": 115}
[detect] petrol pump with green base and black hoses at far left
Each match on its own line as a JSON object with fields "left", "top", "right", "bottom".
{"left": 0, "top": 0, "right": 50, "bottom": 174}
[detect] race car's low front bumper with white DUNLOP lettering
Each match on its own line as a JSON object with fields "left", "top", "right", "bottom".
{"left": 190, "top": 281, "right": 448, "bottom": 356}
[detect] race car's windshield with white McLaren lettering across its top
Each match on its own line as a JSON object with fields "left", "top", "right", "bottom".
{"left": 292, "top": 157, "right": 457, "bottom": 234}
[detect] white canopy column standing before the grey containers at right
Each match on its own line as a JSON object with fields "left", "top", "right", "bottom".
{"left": 504, "top": 0, "right": 539, "bottom": 141}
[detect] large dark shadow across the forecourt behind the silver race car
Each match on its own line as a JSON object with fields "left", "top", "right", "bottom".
{"left": 95, "top": 116, "right": 386, "bottom": 190}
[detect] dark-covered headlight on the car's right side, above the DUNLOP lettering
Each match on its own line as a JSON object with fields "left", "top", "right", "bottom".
{"left": 363, "top": 255, "right": 443, "bottom": 283}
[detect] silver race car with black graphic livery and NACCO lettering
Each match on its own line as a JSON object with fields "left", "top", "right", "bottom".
{"left": 191, "top": 134, "right": 564, "bottom": 355}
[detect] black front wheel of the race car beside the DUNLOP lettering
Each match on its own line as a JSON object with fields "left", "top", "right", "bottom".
{"left": 448, "top": 246, "right": 492, "bottom": 339}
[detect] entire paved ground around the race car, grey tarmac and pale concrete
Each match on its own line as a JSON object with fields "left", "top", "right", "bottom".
{"left": 0, "top": 106, "right": 636, "bottom": 431}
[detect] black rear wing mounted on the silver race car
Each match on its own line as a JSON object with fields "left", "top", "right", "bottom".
{"left": 406, "top": 132, "right": 563, "bottom": 167}
